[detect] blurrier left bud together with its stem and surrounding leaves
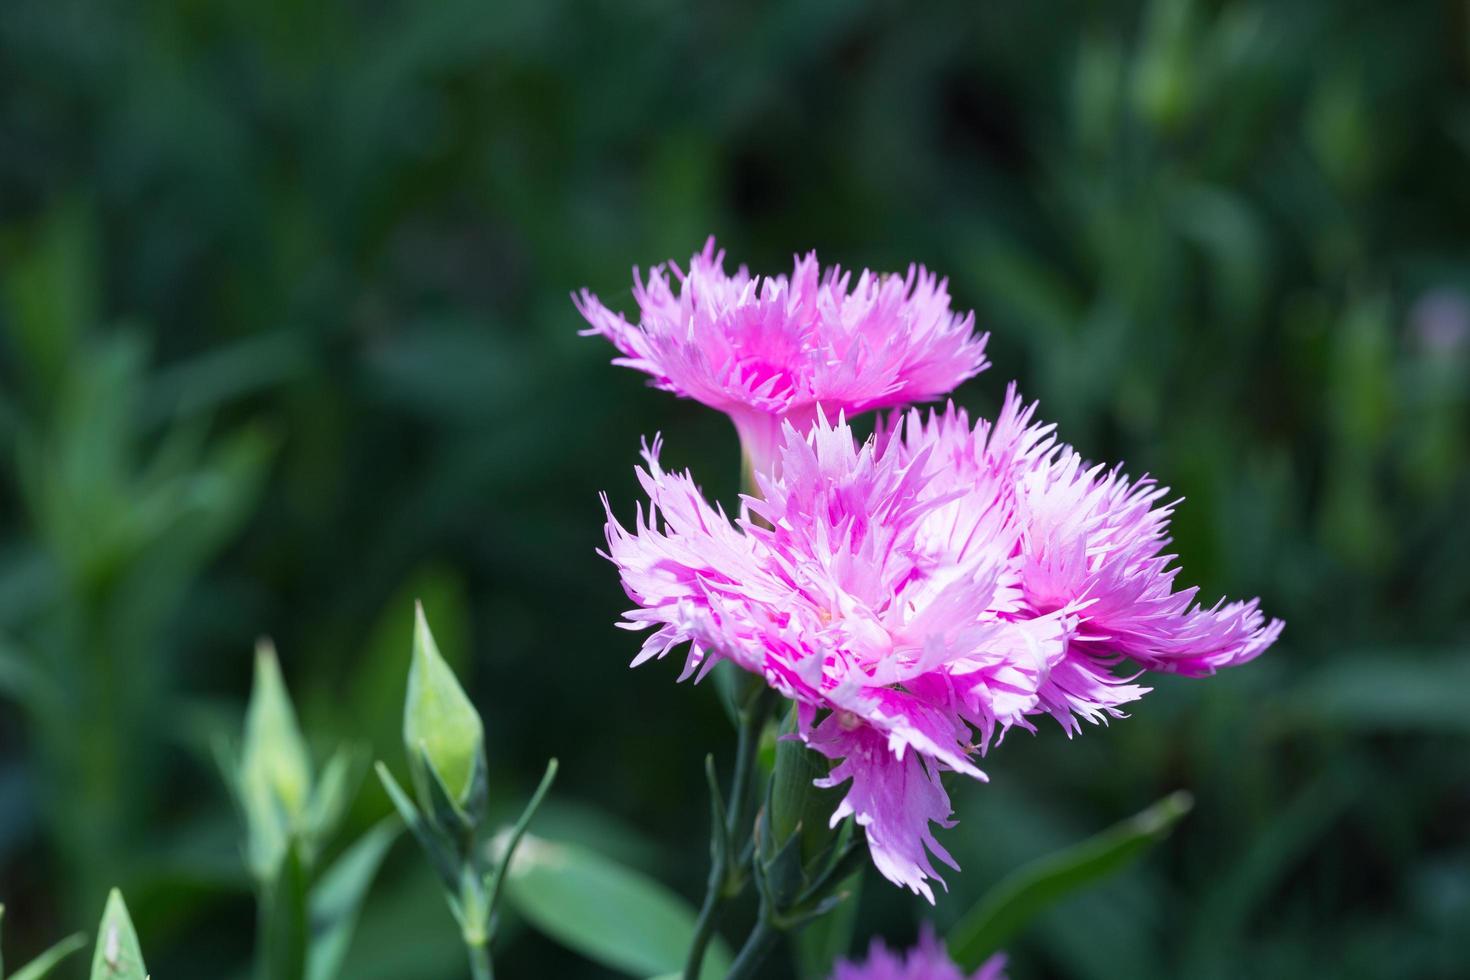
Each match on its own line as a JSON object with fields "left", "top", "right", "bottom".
{"left": 219, "top": 642, "right": 400, "bottom": 980}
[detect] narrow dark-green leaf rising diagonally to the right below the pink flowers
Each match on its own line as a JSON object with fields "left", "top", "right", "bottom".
{"left": 948, "top": 792, "right": 1194, "bottom": 970}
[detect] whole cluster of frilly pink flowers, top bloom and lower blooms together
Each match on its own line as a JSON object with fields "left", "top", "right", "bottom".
{"left": 582, "top": 238, "right": 1282, "bottom": 902}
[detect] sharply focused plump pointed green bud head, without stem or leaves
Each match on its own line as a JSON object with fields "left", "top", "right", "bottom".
{"left": 403, "top": 604, "right": 485, "bottom": 817}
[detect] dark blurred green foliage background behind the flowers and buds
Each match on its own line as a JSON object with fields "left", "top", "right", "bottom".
{"left": 0, "top": 0, "right": 1470, "bottom": 980}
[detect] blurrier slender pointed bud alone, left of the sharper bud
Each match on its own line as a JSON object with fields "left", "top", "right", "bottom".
{"left": 238, "top": 641, "right": 312, "bottom": 879}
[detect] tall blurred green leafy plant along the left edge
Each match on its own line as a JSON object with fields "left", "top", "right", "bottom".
{"left": 0, "top": 201, "right": 270, "bottom": 909}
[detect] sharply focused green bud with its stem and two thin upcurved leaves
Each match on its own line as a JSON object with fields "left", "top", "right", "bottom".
{"left": 378, "top": 605, "right": 557, "bottom": 980}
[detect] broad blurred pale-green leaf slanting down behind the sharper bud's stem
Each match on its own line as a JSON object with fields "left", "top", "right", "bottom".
{"left": 506, "top": 835, "right": 731, "bottom": 980}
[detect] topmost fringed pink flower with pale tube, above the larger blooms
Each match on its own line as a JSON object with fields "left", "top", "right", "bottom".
{"left": 573, "top": 238, "right": 986, "bottom": 472}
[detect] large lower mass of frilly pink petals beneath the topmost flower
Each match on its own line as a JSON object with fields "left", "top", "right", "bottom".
{"left": 604, "top": 386, "right": 1282, "bottom": 902}
